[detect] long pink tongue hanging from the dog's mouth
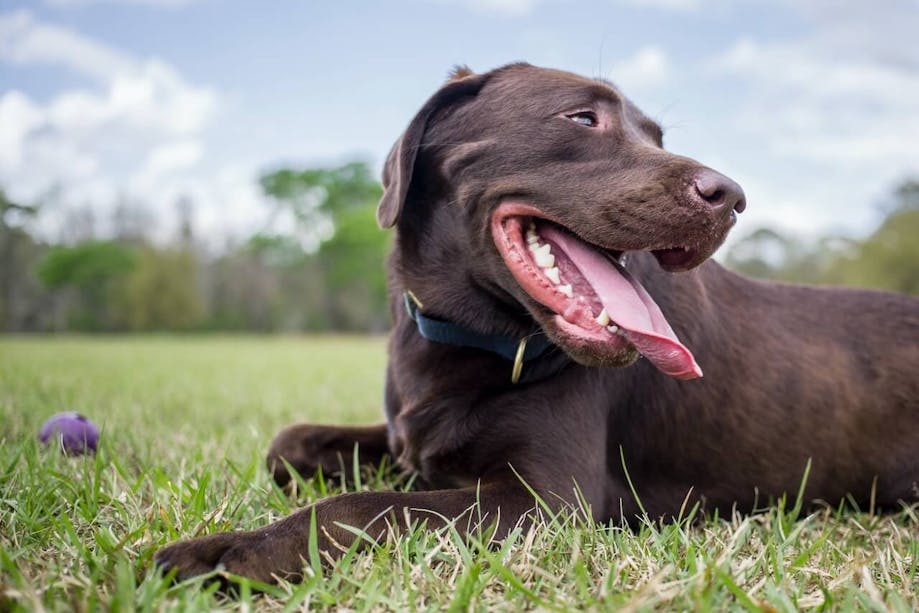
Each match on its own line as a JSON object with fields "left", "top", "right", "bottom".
{"left": 539, "top": 226, "right": 702, "bottom": 379}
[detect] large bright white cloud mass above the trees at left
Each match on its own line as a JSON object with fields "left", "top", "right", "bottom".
{"left": 0, "top": 11, "right": 266, "bottom": 244}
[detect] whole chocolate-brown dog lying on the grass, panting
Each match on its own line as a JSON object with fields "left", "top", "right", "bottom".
{"left": 157, "top": 64, "right": 919, "bottom": 581}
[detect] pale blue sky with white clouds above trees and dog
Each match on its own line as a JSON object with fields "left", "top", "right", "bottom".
{"left": 0, "top": 0, "right": 919, "bottom": 249}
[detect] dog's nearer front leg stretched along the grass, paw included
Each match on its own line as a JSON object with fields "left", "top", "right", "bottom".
{"left": 156, "top": 482, "right": 535, "bottom": 583}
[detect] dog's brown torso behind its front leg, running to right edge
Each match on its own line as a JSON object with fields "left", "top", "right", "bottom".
{"left": 608, "top": 262, "right": 919, "bottom": 514}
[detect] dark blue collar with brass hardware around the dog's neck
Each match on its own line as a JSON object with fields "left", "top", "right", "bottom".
{"left": 402, "top": 290, "right": 568, "bottom": 383}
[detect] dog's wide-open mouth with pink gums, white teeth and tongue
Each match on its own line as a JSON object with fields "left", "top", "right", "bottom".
{"left": 492, "top": 203, "right": 702, "bottom": 379}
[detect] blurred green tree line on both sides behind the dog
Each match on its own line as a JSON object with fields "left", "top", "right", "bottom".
{"left": 0, "top": 170, "right": 919, "bottom": 332}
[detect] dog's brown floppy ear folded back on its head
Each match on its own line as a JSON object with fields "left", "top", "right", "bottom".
{"left": 377, "top": 66, "right": 486, "bottom": 228}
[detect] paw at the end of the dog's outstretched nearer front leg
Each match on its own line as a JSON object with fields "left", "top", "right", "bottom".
{"left": 154, "top": 531, "right": 299, "bottom": 583}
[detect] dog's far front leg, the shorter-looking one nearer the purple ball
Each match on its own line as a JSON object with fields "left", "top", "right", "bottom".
{"left": 267, "top": 424, "right": 389, "bottom": 486}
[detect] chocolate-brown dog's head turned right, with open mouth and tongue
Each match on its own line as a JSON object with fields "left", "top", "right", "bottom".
{"left": 378, "top": 64, "right": 744, "bottom": 378}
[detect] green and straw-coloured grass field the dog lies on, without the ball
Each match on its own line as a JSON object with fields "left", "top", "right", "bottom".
{"left": 0, "top": 337, "right": 919, "bottom": 611}
